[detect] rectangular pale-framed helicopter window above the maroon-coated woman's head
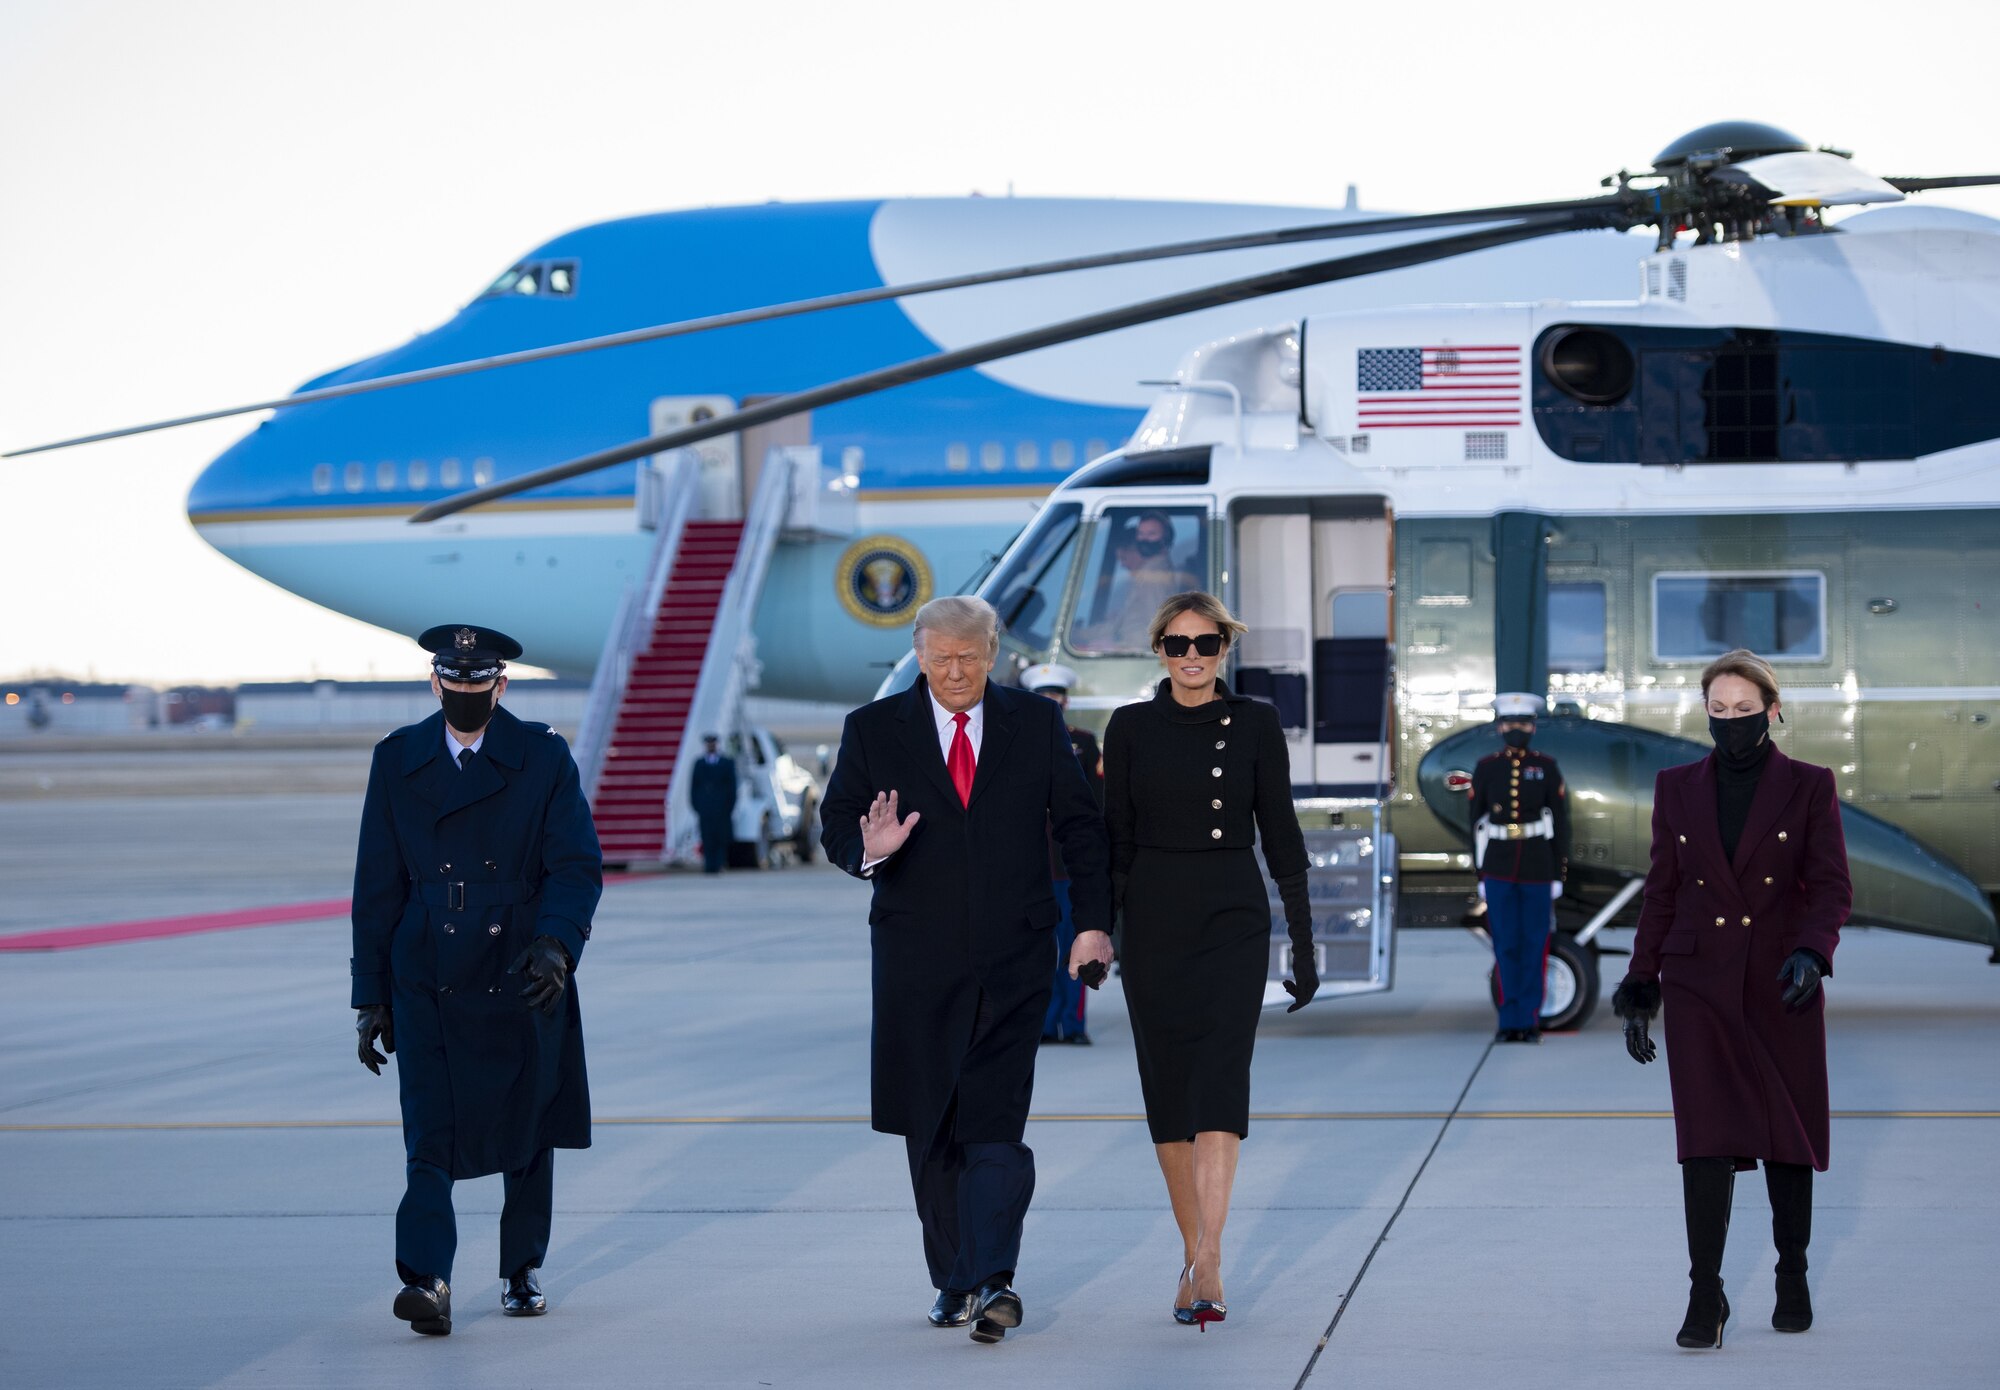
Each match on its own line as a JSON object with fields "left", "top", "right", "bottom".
{"left": 1652, "top": 570, "right": 1826, "bottom": 662}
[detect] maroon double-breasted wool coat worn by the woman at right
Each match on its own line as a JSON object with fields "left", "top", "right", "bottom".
{"left": 1626, "top": 748, "right": 1854, "bottom": 1172}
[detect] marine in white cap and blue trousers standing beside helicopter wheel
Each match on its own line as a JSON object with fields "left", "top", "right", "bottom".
{"left": 1472, "top": 694, "right": 1570, "bottom": 1042}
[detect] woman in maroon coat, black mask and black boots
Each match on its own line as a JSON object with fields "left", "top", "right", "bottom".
{"left": 1612, "top": 650, "right": 1854, "bottom": 1346}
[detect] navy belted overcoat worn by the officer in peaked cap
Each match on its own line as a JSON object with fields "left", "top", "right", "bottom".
{"left": 352, "top": 708, "right": 604, "bottom": 1178}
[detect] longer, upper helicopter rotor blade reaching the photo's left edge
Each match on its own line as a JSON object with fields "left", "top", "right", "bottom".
{"left": 0, "top": 194, "right": 1622, "bottom": 458}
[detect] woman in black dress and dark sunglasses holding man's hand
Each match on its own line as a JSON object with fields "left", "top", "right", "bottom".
{"left": 1104, "top": 592, "right": 1320, "bottom": 1330}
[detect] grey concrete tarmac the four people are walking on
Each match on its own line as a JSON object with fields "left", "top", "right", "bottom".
{"left": 0, "top": 748, "right": 2000, "bottom": 1390}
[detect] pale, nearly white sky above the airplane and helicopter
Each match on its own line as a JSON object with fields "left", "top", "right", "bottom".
{"left": 0, "top": 0, "right": 2000, "bottom": 682}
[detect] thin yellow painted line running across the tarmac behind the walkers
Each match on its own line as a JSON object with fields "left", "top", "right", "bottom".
{"left": 0, "top": 1110, "right": 2000, "bottom": 1134}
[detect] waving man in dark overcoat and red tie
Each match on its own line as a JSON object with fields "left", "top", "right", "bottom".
{"left": 820, "top": 598, "right": 1110, "bottom": 1342}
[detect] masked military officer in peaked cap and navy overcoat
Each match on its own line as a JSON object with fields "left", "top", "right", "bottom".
{"left": 352, "top": 624, "right": 604, "bottom": 1334}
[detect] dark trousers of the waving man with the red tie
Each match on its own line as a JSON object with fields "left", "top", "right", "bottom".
{"left": 904, "top": 996, "right": 1034, "bottom": 1294}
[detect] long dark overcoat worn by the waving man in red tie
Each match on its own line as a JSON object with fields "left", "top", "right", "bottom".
{"left": 820, "top": 680, "right": 1110, "bottom": 1142}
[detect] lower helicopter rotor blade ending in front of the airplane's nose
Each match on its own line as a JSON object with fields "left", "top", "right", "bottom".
{"left": 410, "top": 208, "right": 1614, "bottom": 524}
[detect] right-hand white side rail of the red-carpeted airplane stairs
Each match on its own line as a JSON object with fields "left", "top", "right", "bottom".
{"left": 660, "top": 448, "right": 796, "bottom": 862}
